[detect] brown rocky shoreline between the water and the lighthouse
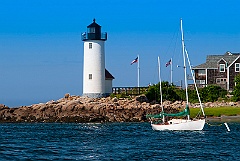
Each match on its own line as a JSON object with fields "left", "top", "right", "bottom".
{"left": 0, "top": 94, "right": 240, "bottom": 123}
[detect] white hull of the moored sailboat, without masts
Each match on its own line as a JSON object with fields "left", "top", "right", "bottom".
{"left": 151, "top": 119, "right": 205, "bottom": 131}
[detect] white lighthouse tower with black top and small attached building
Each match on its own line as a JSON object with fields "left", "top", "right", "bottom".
{"left": 82, "top": 19, "right": 114, "bottom": 98}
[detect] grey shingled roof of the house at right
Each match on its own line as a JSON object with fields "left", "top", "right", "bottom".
{"left": 193, "top": 51, "right": 240, "bottom": 69}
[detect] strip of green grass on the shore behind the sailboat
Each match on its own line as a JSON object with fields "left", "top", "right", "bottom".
{"left": 190, "top": 106, "right": 240, "bottom": 117}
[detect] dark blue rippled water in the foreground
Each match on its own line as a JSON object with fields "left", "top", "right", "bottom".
{"left": 0, "top": 123, "right": 240, "bottom": 160}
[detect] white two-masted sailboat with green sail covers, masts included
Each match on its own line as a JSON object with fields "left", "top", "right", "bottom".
{"left": 147, "top": 19, "right": 205, "bottom": 131}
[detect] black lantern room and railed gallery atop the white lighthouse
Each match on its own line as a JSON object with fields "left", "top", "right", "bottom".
{"left": 82, "top": 19, "right": 107, "bottom": 41}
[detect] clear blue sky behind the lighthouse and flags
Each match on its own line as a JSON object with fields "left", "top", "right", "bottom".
{"left": 0, "top": 0, "right": 240, "bottom": 107}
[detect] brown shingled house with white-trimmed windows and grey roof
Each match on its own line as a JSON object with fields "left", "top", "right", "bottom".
{"left": 193, "top": 52, "right": 240, "bottom": 91}
